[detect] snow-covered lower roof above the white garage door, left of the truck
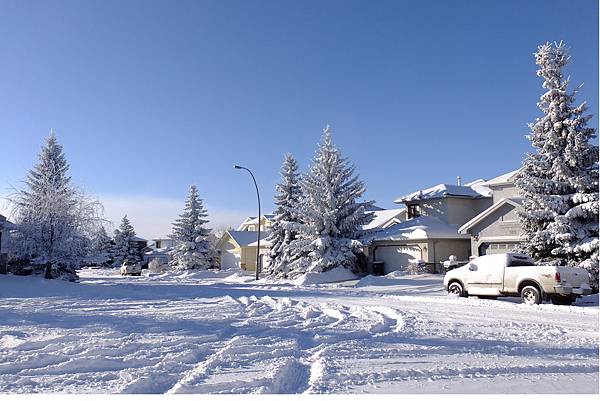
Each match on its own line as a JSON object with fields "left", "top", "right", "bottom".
{"left": 363, "top": 216, "right": 469, "bottom": 243}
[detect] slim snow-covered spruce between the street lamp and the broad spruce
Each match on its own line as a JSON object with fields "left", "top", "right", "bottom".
{"left": 267, "top": 154, "right": 302, "bottom": 277}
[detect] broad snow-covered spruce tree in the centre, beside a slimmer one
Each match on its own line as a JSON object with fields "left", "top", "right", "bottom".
{"left": 288, "top": 126, "right": 373, "bottom": 278}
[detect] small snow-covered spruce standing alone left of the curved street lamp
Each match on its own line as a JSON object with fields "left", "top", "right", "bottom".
{"left": 169, "top": 185, "right": 216, "bottom": 270}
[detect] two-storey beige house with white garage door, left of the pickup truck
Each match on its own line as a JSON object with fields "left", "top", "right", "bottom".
{"left": 363, "top": 180, "right": 492, "bottom": 273}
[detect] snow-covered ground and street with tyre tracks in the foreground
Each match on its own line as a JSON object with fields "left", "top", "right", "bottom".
{"left": 0, "top": 269, "right": 598, "bottom": 393}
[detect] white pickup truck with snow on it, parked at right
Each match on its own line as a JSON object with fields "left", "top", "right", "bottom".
{"left": 444, "top": 253, "right": 592, "bottom": 305}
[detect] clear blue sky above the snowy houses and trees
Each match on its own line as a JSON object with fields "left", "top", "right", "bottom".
{"left": 0, "top": 0, "right": 598, "bottom": 235}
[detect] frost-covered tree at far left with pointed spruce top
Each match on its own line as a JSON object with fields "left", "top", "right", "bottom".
{"left": 11, "top": 133, "right": 101, "bottom": 280}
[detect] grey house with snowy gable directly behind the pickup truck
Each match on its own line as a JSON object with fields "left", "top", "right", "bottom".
{"left": 459, "top": 170, "right": 523, "bottom": 256}
